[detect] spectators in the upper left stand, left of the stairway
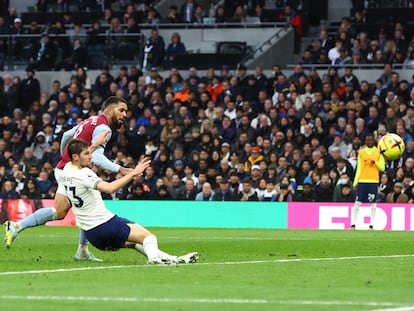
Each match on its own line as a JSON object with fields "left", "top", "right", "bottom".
{"left": 0, "top": 0, "right": 302, "bottom": 70}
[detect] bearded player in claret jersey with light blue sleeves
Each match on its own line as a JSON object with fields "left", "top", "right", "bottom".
{"left": 5, "top": 96, "right": 130, "bottom": 261}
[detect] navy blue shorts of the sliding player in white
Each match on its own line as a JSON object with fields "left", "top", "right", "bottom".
{"left": 85, "top": 215, "right": 133, "bottom": 251}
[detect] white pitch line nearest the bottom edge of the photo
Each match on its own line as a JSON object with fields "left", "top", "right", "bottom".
{"left": 0, "top": 295, "right": 413, "bottom": 311}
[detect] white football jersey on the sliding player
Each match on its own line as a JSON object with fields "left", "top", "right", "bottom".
{"left": 61, "top": 162, "right": 114, "bottom": 230}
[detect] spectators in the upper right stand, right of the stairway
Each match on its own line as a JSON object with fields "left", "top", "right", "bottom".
{"left": 301, "top": 9, "right": 414, "bottom": 68}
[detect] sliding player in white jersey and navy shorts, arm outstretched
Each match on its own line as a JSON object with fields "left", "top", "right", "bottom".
{"left": 61, "top": 139, "right": 199, "bottom": 264}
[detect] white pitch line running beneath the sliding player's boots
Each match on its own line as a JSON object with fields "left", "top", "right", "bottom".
{"left": 0, "top": 254, "right": 414, "bottom": 276}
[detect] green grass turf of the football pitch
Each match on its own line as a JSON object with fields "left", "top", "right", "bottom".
{"left": 0, "top": 227, "right": 414, "bottom": 311}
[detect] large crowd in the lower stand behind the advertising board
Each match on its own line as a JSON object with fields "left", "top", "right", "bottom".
{"left": 0, "top": 0, "right": 414, "bottom": 203}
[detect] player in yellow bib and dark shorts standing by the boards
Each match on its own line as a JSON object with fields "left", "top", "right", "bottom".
{"left": 351, "top": 134, "right": 385, "bottom": 230}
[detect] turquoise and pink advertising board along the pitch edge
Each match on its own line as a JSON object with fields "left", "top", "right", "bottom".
{"left": 0, "top": 200, "right": 414, "bottom": 231}
